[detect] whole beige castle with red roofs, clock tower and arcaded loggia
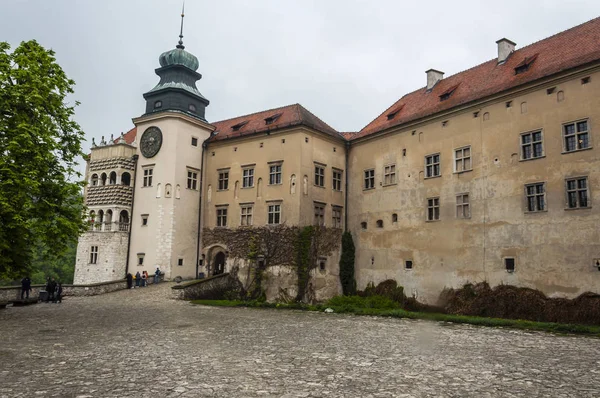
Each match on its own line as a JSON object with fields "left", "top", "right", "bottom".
{"left": 75, "top": 18, "right": 600, "bottom": 303}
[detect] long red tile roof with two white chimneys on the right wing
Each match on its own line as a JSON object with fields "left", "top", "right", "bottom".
{"left": 351, "top": 18, "right": 600, "bottom": 139}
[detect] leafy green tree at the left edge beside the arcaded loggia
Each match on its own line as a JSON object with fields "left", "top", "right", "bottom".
{"left": 0, "top": 40, "right": 85, "bottom": 279}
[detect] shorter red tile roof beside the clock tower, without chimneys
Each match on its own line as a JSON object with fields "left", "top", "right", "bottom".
{"left": 211, "top": 104, "right": 344, "bottom": 141}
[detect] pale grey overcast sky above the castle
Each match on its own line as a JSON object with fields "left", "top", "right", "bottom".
{"left": 0, "top": 0, "right": 600, "bottom": 162}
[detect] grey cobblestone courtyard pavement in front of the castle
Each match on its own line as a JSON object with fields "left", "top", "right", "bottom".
{"left": 0, "top": 283, "right": 600, "bottom": 397}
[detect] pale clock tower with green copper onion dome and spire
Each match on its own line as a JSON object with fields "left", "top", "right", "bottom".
{"left": 128, "top": 12, "right": 214, "bottom": 279}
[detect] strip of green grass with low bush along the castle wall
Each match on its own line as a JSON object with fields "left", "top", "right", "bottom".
{"left": 192, "top": 296, "right": 600, "bottom": 337}
